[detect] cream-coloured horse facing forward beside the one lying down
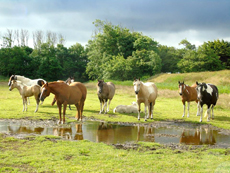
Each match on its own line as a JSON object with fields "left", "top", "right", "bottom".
{"left": 133, "top": 78, "right": 157, "bottom": 121}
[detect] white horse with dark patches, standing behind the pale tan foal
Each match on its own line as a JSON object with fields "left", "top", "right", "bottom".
{"left": 8, "top": 75, "right": 46, "bottom": 104}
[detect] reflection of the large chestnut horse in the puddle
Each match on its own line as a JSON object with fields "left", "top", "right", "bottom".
{"left": 53, "top": 124, "right": 83, "bottom": 140}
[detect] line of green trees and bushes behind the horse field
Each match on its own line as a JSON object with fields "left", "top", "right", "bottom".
{"left": 0, "top": 20, "right": 230, "bottom": 81}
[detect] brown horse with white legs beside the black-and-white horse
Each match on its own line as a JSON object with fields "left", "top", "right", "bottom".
{"left": 178, "top": 81, "right": 200, "bottom": 117}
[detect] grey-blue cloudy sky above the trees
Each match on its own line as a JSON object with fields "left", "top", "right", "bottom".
{"left": 0, "top": 0, "right": 230, "bottom": 47}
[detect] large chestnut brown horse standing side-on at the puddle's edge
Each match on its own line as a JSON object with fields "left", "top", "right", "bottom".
{"left": 40, "top": 82, "right": 87, "bottom": 123}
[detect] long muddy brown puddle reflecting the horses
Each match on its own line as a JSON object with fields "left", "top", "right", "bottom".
{"left": 0, "top": 121, "right": 230, "bottom": 147}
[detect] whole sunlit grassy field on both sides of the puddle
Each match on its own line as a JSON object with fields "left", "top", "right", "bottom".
{"left": 0, "top": 70, "right": 230, "bottom": 172}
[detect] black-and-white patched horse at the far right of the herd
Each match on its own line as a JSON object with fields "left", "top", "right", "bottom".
{"left": 196, "top": 82, "right": 219, "bottom": 122}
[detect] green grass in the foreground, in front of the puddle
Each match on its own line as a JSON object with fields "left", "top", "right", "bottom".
{"left": 0, "top": 135, "right": 230, "bottom": 173}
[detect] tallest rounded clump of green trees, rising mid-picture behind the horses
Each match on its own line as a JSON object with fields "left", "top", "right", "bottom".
{"left": 86, "top": 20, "right": 161, "bottom": 80}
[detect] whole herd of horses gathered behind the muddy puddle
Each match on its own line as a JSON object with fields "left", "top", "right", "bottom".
{"left": 8, "top": 75, "right": 219, "bottom": 124}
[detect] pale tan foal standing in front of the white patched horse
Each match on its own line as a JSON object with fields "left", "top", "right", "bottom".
{"left": 9, "top": 80, "right": 41, "bottom": 112}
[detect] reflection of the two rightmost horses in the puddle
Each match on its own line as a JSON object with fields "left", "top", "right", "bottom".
{"left": 180, "top": 127, "right": 218, "bottom": 145}
